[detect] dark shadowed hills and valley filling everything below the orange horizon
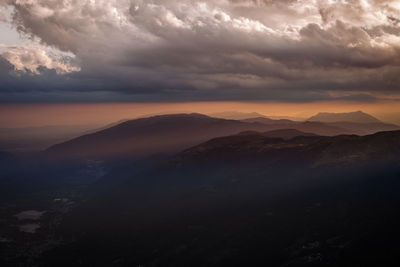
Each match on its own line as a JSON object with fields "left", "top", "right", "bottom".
{"left": 0, "top": 114, "right": 400, "bottom": 267}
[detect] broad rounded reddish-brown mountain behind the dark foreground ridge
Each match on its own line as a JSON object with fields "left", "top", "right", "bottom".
{"left": 47, "top": 114, "right": 348, "bottom": 159}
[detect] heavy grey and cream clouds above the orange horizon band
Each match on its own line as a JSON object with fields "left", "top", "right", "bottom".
{"left": 0, "top": 0, "right": 400, "bottom": 103}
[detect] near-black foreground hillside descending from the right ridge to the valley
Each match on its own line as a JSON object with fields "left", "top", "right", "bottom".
{"left": 22, "top": 131, "right": 400, "bottom": 266}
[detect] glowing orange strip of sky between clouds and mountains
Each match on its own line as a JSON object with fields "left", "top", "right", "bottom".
{"left": 0, "top": 102, "right": 400, "bottom": 128}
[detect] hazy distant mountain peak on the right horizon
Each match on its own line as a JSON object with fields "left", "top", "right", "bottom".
{"left": 308, "top": 110, "right": 382, "bottom": 123}
